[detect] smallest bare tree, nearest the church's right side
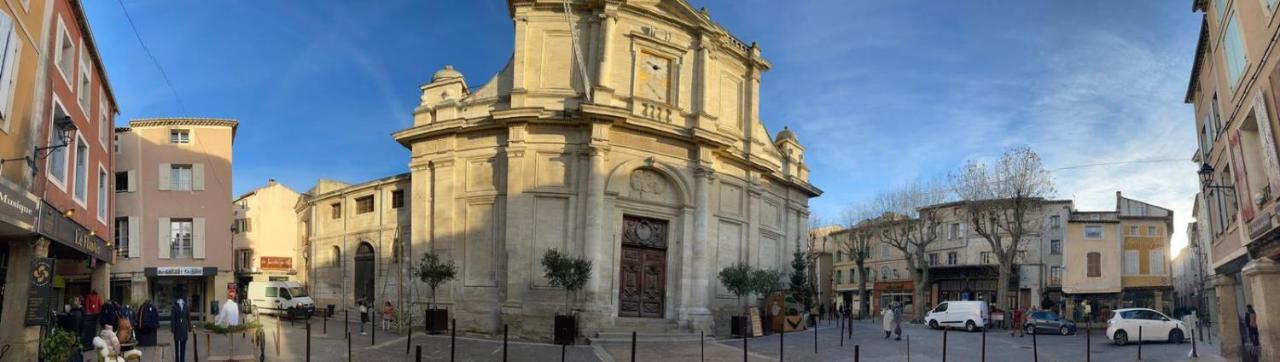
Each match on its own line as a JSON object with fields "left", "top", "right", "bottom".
{"left": 837, "top": 205, "right": 879, "bottom": 317}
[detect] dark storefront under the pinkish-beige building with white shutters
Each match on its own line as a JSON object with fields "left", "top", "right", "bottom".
{"left": 142, "top": 266, "right": 219, "bottom": 319}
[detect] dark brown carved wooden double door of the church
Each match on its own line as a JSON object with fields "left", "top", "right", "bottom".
{"left": 618, "top": 216, "right": 668, "bottom": 319}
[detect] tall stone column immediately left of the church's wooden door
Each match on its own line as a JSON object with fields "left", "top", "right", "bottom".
{"left": 582, "top": 145, "right": 613, "bottom": 306}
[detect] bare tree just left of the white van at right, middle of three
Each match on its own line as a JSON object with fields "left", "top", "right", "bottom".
{"left": 869, "top": 182, "right": 946, "bottom": 321}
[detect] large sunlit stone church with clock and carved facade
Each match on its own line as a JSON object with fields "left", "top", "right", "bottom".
{"left": 393, "top": 0, "right": 822, "bottom": 335}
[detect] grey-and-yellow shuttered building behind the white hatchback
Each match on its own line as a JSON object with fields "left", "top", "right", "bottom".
{"left": 1062, "top": 192, "right": 1174, "bottom": 317}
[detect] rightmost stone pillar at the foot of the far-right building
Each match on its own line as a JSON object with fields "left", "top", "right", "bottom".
{"left": 1240, "top": 257, "right": 1280, "bottom": 361}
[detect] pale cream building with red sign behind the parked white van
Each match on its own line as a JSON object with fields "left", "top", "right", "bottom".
{"left": 232, "top": 179, "right": 302, "bottom": 286}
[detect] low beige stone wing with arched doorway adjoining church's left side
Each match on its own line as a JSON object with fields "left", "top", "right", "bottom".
{"left": 294, "top": 174, "right": 407, "bottom": 315}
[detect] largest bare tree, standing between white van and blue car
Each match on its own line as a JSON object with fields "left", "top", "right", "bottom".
{"left": 951, "top": 147, "right": 1053, "bottom": 310}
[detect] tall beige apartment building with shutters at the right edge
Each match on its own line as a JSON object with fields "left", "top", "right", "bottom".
{"left": 1185, "top": 0, "right": 1280, "bottom": 361}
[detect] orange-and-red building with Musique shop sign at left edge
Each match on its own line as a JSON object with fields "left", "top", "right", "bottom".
{"left": 0, "top": 0, "right": 116, "bottom": 361}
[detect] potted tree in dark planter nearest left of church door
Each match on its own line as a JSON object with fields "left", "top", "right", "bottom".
{"left": 543, "top": 249, "right": 591, "bottom": 344}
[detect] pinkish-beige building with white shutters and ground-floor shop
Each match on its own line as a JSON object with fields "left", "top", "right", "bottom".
{"left": 111, "top": 118, "right": 238, "bottom": 315}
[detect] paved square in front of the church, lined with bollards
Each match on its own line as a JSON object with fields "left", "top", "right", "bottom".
{"left": 86, "top": 317, "right": 1225, "bottom": 362}
